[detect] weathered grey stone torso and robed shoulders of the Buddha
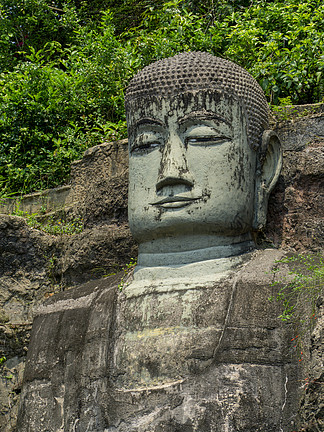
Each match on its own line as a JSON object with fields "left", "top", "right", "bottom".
{"left": 17, "top": 250, "right": 298, "bottom": 432}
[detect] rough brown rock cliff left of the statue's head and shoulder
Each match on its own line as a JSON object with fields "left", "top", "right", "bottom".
{"left": 0, "top": 141, "right": 137, "bottom": 432}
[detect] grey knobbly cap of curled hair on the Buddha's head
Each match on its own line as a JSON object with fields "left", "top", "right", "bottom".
{"left": 125, "top": 52, "right": 269, "bottom": 150}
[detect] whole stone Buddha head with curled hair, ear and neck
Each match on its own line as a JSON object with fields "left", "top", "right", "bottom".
{"left": 125, "top": 52, "right": 281, "bottom": 266}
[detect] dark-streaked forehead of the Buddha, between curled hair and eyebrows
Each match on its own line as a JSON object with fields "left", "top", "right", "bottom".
{"left": 127, "top": 91, "right": 244, "bottom": 129}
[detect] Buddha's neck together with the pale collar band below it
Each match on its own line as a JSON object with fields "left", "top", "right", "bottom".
{"left": 127, "top": 234, "right": 254, "bottom": 297}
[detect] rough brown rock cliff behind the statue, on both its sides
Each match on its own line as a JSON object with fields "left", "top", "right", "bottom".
{"left": 0, "top": 107, "right": 324, "bottom": 432}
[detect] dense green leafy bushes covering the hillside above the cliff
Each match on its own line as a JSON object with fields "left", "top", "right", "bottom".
{"left": 0, "top": 0, "right": 324, "bottom": 196}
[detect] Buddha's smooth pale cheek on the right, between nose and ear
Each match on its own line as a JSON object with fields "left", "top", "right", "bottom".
{"left": 186, "top": 141, "right": 256, "bottom": 234}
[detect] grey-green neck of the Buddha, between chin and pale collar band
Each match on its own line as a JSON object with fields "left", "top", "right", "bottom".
{"left": 138, "top": 233, "right": 254, "bottom": 268}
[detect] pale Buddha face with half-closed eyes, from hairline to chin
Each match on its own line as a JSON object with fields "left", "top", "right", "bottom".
{"left": 128, "top": 92, "right": 256, "bottom": 243}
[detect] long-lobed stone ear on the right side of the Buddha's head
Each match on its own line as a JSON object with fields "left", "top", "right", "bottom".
{"left": 253, "top": 130, "right": 282, "bottom": 230}
